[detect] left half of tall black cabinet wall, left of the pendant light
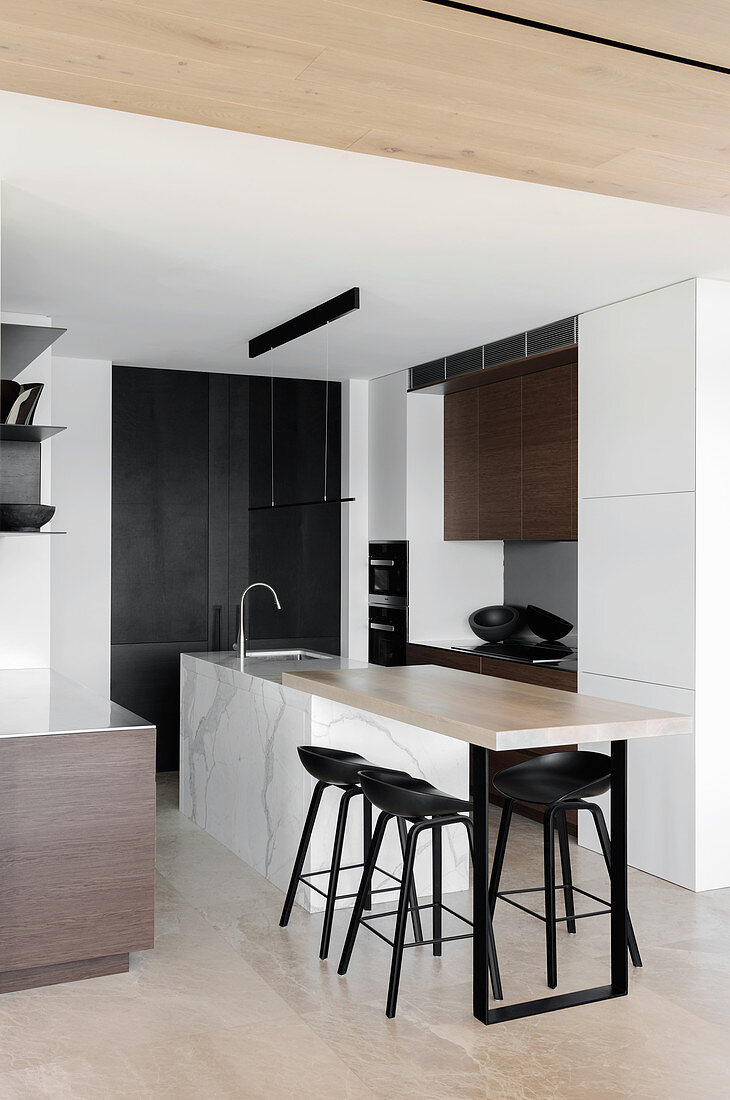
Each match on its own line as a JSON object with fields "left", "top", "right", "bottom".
{"left": 111, "top": 366, "right": 248, "bottom": 771}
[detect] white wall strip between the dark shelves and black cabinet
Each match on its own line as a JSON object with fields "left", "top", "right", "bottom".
{"left": 46, "top": 355, "right": 111, "bottom": 696}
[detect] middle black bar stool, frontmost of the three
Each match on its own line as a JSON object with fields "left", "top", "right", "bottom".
{"left": 338, "top": 771, "right": 502, "bottom": 1019}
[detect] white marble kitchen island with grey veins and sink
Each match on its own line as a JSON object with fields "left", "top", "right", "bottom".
{"left": 180, "top": 652, "right": 468, "bottom": 912}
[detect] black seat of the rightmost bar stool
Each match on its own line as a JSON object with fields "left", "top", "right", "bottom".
{"left": 494, "top": 750, "right": 611, "bottom": 806}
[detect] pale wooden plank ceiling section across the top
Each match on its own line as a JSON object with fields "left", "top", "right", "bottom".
{"left": 0, "top": 0, "right": 730, "bottom": 213}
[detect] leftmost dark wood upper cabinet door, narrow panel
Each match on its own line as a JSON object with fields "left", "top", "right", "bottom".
{"left": 443, "top": 391, "right": 479, "bottom": 540}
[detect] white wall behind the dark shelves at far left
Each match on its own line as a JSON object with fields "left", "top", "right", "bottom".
{"left": 0, "top": 314, "right": 53, "bottom": 669}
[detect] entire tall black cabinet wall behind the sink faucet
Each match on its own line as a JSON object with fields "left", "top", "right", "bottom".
{"left": 111, "top": 366, "right": 341, "bottom": 771}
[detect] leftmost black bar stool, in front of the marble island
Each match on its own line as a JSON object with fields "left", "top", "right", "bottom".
{"left": 279, "top": 745, "right": 423, "bottom": 959}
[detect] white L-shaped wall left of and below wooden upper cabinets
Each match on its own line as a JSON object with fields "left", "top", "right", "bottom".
{"left": 406, "top": 394, "right": 505, "bottom": 642}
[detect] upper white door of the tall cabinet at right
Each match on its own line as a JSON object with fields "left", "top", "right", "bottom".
{"left": 578, "top": 279, "right": 695, "bottom": 496}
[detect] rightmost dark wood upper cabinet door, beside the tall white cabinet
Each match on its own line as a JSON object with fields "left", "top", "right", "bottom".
{"left": 525, "top": 364, "right": 577, "bottom": 540}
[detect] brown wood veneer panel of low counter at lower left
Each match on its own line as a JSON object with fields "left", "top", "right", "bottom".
{"left": 0, "top": 728, "right": 155, "bottom": 988}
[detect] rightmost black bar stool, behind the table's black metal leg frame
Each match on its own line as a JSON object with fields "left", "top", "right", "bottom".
{"left": 489, "top": 750, "right": 641, "bottom": 989}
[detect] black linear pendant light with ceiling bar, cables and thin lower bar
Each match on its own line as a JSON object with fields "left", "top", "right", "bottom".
{"left": 248, "top": 287, "right": 360, "bottom": 512}
